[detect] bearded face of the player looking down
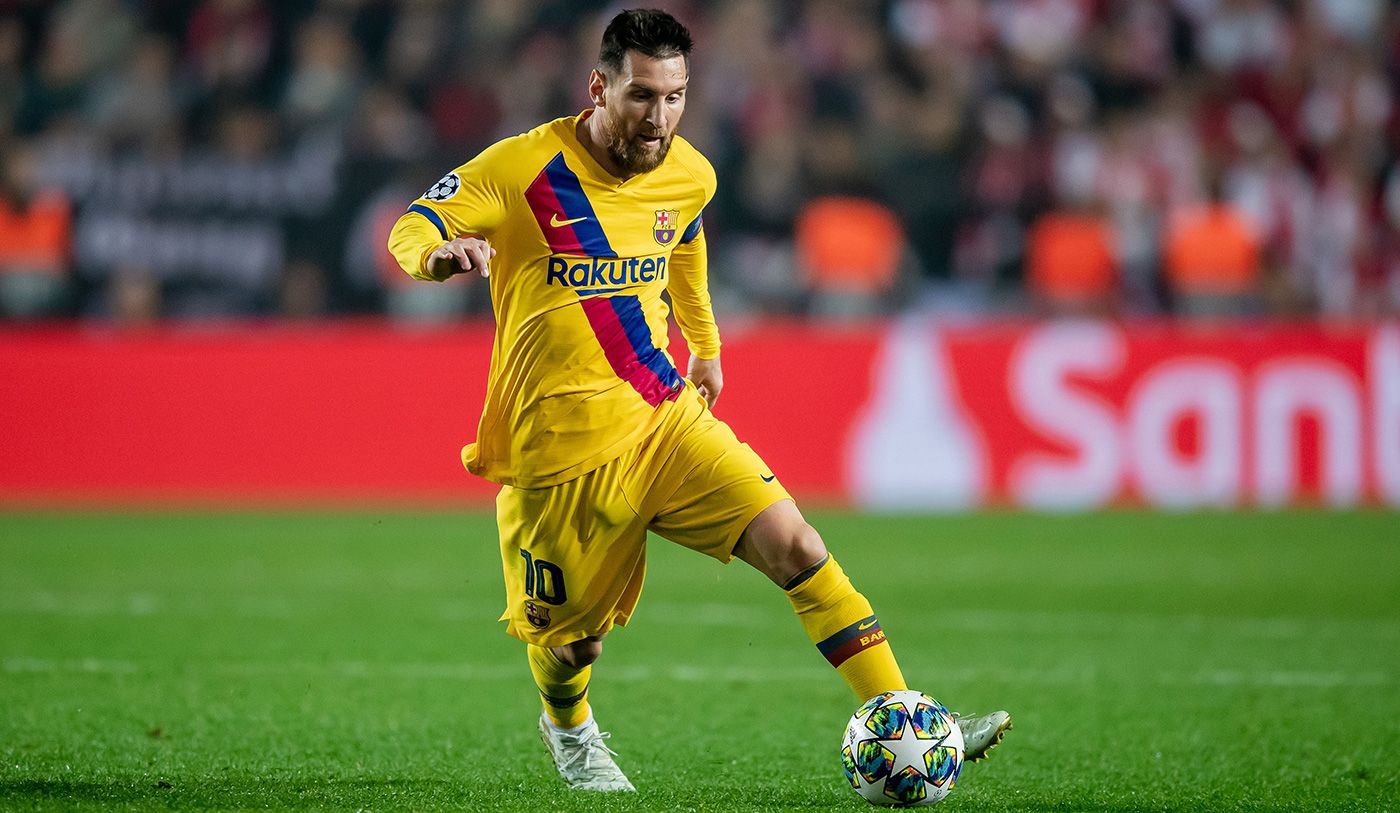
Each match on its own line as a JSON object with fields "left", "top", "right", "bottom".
{"left": 594, "top": 50, "right": 690, "bottom": 175}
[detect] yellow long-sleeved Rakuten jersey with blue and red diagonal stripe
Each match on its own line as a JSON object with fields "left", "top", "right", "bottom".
{"left": 389, "top": 111, "right": 720, "bottom": 488}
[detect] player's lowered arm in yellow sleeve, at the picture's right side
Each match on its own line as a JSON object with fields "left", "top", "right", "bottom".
{"left": 666, "top": 215, "right": 724, "bottom": 407}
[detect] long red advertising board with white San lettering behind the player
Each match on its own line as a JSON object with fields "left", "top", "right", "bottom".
{"left": 0, "top": 319, "right": 1400, "bottom": 509}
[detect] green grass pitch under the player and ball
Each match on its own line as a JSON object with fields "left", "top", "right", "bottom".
{"left": 0, "top": 512, "right": 1400, "bottom": 812}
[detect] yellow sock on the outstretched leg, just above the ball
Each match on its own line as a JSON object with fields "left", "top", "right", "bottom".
{"left": 783, "top": 556, "right": 907, "bottom": 700}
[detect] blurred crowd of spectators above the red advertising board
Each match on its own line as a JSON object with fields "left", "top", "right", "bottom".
{"left": 0, "top": 0, "right": 1400, "bottom": 323}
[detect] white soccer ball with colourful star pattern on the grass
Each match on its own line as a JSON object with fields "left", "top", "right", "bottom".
{"left": 841, "top": 688, "right": 963, "bottom": 807}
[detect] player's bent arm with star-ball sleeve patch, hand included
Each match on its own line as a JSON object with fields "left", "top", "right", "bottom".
{"left": 389, "top": 141, "right": 514, "bottom": 281}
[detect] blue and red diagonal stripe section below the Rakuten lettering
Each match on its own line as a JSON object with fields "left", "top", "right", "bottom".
{"left": 578, "top": 297, "right": 682, "bottom": 406}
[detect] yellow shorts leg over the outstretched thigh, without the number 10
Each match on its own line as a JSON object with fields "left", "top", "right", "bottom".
{"left": 651, "top": 413, "right": 792, "bottom": 561}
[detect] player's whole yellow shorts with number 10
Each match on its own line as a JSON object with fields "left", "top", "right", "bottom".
{"left": 496, "top": 383, "right": 791, "bottom": 646}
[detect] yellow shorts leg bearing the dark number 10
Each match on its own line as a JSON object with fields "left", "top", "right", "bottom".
{"left": 496, "top": 474, "right": 645, "bottom": 646}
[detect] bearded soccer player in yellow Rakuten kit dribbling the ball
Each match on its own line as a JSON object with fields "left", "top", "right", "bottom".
{"left": 389, "top": 10, "right": 1011, "bottom": 791}
